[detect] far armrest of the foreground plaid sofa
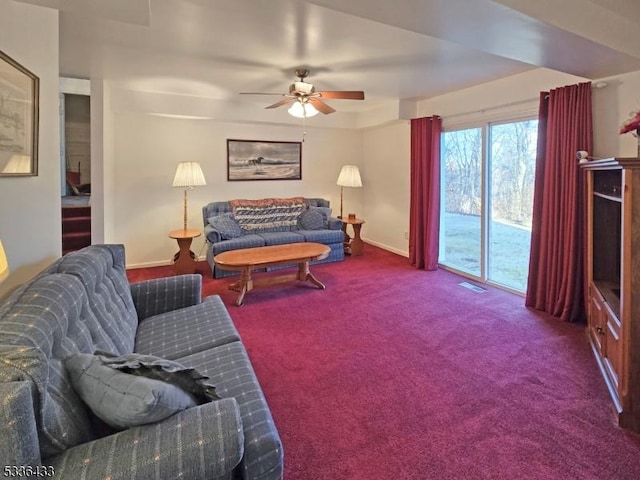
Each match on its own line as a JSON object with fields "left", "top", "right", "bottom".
{"left": 131, "top": 274, "right": 202, "bottom": 321}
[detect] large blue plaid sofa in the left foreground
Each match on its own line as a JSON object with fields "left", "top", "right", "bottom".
{"left": 0, "top": 245, "right": 283, "bottom": 480}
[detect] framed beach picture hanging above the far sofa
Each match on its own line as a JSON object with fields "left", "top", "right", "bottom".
{"left": 227, "top": 139, "right": 302, "bottom": 182}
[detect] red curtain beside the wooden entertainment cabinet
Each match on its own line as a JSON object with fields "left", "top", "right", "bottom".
{"left": 525, "top": 82, "right": 593, "bottom": 321}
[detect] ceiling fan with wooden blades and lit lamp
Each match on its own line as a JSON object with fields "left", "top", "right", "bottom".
{"left": 240, "top": 68, "right": 364, "bottom": 117}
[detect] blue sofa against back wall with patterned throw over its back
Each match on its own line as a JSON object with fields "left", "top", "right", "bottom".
{"left": 202, "top": 197, "right": 344, "bottom": 278}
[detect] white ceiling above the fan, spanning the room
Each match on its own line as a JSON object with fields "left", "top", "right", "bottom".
{"left": 16, "top": 0, "right": 640, "bottom": 115}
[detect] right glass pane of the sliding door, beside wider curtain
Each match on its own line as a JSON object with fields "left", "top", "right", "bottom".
{"left": 487, "top": 120, "right": 538, "bottom": 291}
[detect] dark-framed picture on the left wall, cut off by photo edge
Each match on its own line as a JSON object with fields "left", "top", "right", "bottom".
{"left": 0, "top": 51, "right": 40, "bottom": 177}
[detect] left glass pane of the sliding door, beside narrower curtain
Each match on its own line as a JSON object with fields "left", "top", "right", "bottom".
{"left": 440, "top": 128, "right": 482, "bottom": 276}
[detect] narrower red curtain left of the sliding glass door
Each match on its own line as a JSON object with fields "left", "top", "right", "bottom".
{"left": 409, "top": 116, "right": 442, "bottom": 270}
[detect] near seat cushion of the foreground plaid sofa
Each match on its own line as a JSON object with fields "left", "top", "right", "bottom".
{"left": 178, "top": 342, "right": 283, "bottom": 478}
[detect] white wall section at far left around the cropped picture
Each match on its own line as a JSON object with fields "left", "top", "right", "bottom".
{"left": 0, "top": 0, "right": 62, "bottom": 298}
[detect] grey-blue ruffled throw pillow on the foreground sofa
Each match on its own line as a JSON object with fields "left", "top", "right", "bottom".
{"left": 64, "top": 352, "right": 219, "bottom": 429}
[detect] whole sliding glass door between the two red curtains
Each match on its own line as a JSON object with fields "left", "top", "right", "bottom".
{"left": 439, "top": 120, "right": 537, "bottom": 291}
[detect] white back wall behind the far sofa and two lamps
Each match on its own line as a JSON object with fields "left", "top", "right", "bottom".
{"left": 105, "top": 108, "right": 362, "bottom": 266}
